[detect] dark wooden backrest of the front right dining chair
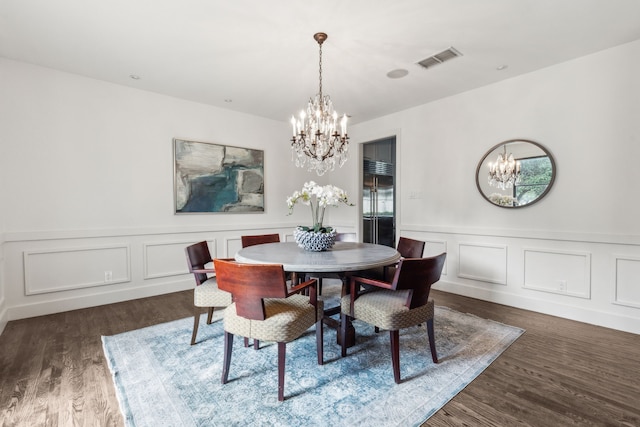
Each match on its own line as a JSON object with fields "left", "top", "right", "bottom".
{"left": 391, "top": 253, "right": 447, "bottom": 309}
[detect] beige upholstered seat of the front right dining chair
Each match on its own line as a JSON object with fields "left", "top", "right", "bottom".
{"left": 341, "top": 289, "right": 434, "bottom": 330}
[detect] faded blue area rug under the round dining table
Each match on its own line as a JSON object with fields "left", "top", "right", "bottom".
{"left": 102, "top": 298, "right": 524, "bottom": 427}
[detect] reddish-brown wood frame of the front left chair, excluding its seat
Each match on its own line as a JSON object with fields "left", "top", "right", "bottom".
{"left": 214, "top": 259, "right": 324, "bottom": 401}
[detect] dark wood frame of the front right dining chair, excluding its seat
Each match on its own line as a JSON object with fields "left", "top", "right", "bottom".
{"left": 340, "top": 253, "right": 446, "bottom": 384}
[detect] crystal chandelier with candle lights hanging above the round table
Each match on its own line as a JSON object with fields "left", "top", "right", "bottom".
{"left": 291, "top": 33, "right": 349, "bottom": 175}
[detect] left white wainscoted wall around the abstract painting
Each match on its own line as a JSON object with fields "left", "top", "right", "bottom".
{"left": 0, "top": 59, "right": 350, "bottom": 327}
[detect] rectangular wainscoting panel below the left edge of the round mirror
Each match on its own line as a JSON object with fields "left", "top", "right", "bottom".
{"left": 458, "top": 243, "right": 507, "bottom": 285}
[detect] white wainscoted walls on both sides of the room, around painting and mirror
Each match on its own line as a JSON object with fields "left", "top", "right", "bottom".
{"left": 0, "top": 38, "right": 640, "bottom": 333}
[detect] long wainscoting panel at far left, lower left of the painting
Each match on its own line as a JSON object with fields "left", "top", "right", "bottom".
{"left": 23, "top": 245, "right": 131, "bottom": 295}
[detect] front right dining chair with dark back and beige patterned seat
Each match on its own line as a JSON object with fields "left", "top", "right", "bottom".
{"left": 340, "top": 253, "right": 447, "bottom": 384}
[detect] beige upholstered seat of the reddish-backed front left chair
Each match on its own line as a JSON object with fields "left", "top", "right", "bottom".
{"left": 224, "top": 295, "right": 324, "bottom": 342}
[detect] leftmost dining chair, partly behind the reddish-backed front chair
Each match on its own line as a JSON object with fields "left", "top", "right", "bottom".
{"left": 185, "top": 241, "right": 232, "bottom": 345}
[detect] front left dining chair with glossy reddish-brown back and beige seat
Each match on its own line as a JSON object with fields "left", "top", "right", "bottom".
{"left": 214, "top": 259, "right": 323, "bottom": 401}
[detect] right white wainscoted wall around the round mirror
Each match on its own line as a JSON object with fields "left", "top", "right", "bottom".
{"left": 351, "top": 41, "right": 640, "bottom": 333}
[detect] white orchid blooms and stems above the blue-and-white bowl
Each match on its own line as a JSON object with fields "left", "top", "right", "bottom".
{"left": 287, "top": 181, "right": 353, "bottom": 233}
